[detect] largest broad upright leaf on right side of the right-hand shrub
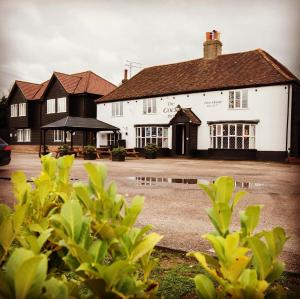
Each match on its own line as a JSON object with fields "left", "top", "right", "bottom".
{"left": 248, "top": 237, "right": 272, "bottom": 280}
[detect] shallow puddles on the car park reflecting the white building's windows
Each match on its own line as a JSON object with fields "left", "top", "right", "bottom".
{"left": 128, "top": 176, "right": 264, "bottom": 189}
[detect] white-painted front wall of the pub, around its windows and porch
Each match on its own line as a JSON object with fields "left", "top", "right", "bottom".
{"left": 97, "top": 85, "right": 288, "bottom": 151}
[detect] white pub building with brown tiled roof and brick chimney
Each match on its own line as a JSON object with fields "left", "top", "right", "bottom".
{"left": 97, "top": 31, "right": 300, "bottom": 160}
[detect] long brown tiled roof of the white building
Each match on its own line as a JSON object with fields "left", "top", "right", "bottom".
{"left": 97, "top": 49, "right": 299, "bottom": 103}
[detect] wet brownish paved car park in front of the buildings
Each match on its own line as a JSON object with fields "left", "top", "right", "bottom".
{"left": 0, "top": 153, "right": 300, "bottom": 272}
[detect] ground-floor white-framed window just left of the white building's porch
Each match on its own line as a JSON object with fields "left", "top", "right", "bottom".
{"left": 135, "top": 127, "right": 168, "bottom": 148}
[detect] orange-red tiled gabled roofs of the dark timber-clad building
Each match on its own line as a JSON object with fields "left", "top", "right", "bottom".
{"left": 9, "top": 71, "right": 116, "bottom": 100}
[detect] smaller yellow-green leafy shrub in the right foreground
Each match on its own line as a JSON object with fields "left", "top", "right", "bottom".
{"left": 189, "top": 177, "right": 287, "bottom": 299}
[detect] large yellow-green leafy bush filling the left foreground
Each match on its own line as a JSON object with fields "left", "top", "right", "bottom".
{"left": 0, "top": 155, "right": 162, "bottom": 299}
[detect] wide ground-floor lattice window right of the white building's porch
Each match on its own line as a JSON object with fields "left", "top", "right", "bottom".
{"left": 209, "top": 123, "right": 255, "bottom": 149}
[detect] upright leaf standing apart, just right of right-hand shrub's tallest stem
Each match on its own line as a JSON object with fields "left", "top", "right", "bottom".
{"left": 240, "top": 205, "right": 262, "bottom": 236}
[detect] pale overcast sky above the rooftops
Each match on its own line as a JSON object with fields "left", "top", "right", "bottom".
{"left": 0, "top": 0, "right": 300, "bottom": 95}
